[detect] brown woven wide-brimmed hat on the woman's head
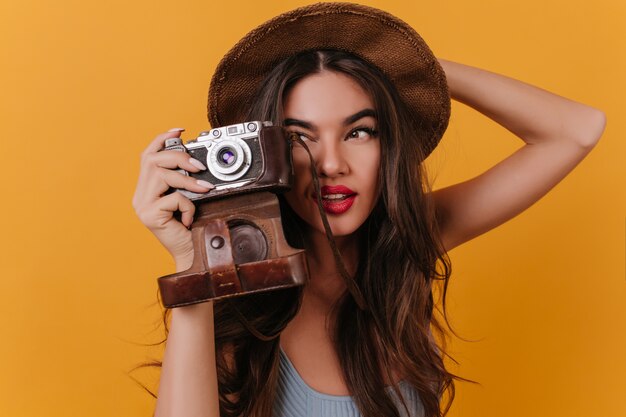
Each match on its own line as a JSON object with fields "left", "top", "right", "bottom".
{"left": 208, "top": 3, "right": 450, "bottom": 155}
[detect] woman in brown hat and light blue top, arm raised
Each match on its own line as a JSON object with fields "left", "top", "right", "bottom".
{"left": 134, "top": 4, "right": 605, "bottom": 416}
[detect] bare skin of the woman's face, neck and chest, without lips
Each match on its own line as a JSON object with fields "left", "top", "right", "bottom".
{"left": 281, "top": 71, "right": 398, "bottom": 395}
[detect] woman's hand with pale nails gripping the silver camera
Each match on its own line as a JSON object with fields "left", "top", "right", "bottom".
{"left": 133, "top": 129, "right": 214, "bottom": 271}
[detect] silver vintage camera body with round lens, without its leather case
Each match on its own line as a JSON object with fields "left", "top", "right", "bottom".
{"left": 165, "top": 121, "right": 292, "bottom": 201}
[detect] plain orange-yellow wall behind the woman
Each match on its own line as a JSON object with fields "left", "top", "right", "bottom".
{"left": 0, "top": 0, "right": 626, "bottom": 417}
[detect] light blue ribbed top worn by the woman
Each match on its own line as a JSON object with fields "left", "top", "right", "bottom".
{"left": 274, "top": 349, "right": 424, "bottom": 417}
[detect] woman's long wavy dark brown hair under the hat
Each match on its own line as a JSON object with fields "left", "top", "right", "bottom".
{"left": 214, "top": 50, "right": 455, "bottom": 417}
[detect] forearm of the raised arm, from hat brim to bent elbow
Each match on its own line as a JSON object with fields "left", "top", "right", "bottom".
{"left": 439, "top": 59, "right": 605, "bottom": 147}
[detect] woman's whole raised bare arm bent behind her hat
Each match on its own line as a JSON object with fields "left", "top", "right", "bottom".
{"left": 432, "top": 59, "right": 606, "bottom": 250}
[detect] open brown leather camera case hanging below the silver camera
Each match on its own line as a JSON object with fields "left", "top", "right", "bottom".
{"left": 158, "top": 192, "right": 308, "bottom": 308}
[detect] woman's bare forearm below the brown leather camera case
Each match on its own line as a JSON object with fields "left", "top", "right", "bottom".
{"left": 155, "top": 302, "right": 219, "bottom": 417}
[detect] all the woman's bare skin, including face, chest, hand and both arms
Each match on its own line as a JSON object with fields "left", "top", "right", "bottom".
{"left": 133, "top": 59, "right": 606, "bottom": 417}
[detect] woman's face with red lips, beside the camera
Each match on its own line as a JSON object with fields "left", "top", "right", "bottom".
{"left": 283, "top": 71, "right": 380, "bottom": 236}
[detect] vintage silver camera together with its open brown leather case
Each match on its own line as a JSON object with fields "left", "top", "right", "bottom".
{"left": 158, "top": 121, "right": 308, "bottom": 308}
